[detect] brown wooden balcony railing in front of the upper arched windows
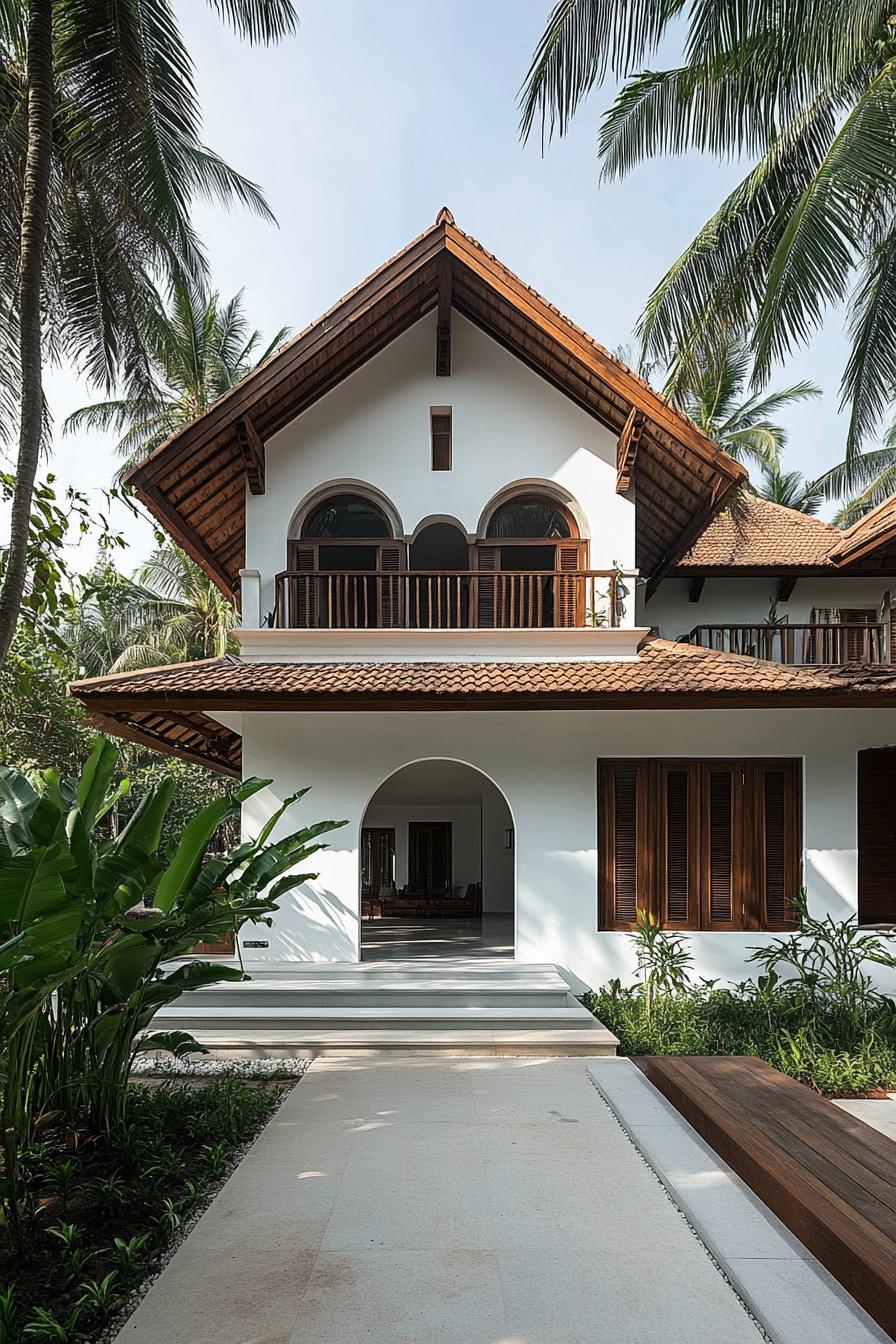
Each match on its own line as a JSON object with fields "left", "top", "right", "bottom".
{"left": 274, "top": 570, "right": 629, "bottom": 630}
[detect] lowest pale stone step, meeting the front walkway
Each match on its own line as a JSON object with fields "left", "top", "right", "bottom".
{"left": 167, "top": 1019, "right": 619, "bottom": 1059}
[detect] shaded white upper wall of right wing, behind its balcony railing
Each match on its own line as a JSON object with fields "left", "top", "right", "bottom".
{"left": 637, "top": 575, "right": 896, "bottom": 640}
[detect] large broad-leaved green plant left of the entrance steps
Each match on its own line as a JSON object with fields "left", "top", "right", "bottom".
{"left": 0, "top": 739, "right": 339, "bottom": 1231}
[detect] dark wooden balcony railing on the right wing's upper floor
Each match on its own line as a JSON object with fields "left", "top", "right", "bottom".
{"left": 685, "top": 621, "right": 891, "bottom": 667}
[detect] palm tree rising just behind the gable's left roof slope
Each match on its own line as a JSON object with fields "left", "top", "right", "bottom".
{"left": 64, "top": 278, "right": 289, "bottom": 473}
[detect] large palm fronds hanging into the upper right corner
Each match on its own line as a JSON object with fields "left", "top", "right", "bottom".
{"left": 521, "top": 0, "right": 896, "bottom": 473}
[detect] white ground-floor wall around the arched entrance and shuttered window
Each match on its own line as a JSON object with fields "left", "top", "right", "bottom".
{"left": 233, "top": 710, "right": 896, "bottom": 989}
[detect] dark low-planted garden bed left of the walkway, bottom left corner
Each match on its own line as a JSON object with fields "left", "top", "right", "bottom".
{"left": 0, "top": 1077, "right": 292, "bottom": 1344}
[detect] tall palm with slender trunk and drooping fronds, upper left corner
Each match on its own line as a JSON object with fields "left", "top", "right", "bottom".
{"left": 0, "top": 0, "right": 296, "bottom": 660}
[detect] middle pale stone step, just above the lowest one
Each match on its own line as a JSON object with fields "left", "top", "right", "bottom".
{"left": 153, "top": 996, "right": 594, "bottom": 1040}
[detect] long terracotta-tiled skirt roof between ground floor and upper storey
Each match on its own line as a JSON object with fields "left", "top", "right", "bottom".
{"left": 70, "top": 638, "right": 896, "bottom": 774}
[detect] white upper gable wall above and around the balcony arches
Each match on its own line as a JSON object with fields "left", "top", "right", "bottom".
{"left": 246, "top": 313, "right": 634, "bottom": 613}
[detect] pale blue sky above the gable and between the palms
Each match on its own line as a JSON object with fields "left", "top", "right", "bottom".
{"left": 38, "top": 0, "right": 844, "bottom": 567}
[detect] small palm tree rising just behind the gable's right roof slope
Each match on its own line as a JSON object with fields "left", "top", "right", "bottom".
{"left": 666, "top": 335, "right": 821, "bottom": 472}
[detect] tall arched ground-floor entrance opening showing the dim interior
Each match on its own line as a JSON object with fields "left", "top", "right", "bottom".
{"left": 360, "top": 758, "right": 516, "bottom": 961}
